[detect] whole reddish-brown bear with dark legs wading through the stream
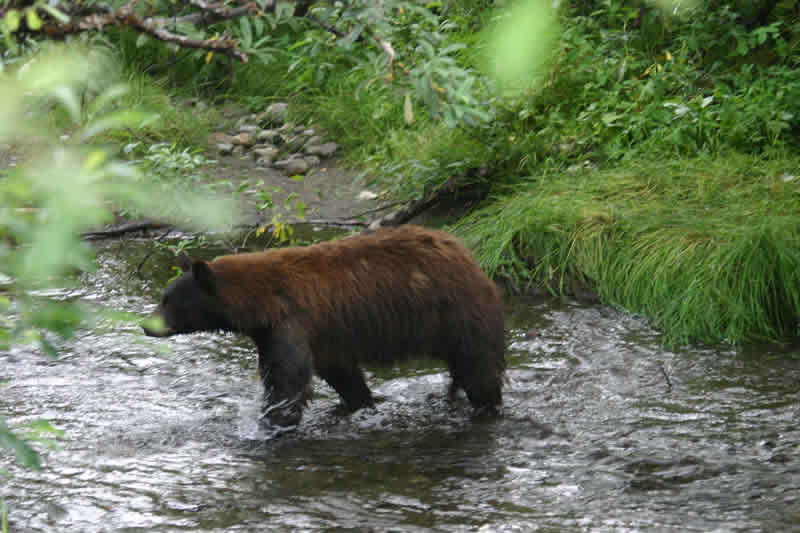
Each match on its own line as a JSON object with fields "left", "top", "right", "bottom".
{"left": 143, "top": 225, "right": 505, "bottom": 426}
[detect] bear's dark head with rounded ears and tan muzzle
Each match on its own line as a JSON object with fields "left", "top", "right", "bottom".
{"left": 142, "top": 252, "right": 231, "bottom": 337}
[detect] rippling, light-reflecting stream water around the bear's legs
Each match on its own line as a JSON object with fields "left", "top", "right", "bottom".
{"left": 0, "top": 241, "right": 800, "bottom": 532}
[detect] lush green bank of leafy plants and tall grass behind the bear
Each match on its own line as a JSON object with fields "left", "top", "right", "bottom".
{"left": 98, "top": 2, "right": 800, "bottom": 343}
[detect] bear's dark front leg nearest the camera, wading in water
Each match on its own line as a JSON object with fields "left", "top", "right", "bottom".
{"left": 250, "top": 327, "right": 313, "bottom": 427}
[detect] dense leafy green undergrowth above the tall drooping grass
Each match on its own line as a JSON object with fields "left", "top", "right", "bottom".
{"left": 294, "top": 0, "right": 800, "bottom": 197}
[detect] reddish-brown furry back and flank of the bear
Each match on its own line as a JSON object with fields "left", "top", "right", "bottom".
{"left": 209, "top": 225, "right": 503, "bottom": 358}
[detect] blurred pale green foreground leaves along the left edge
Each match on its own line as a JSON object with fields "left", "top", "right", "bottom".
{"left": 0, "top": 46, "right": 235, "bottom": 466}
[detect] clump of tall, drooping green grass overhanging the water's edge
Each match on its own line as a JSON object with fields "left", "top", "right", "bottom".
{"left": 455, "top": 155, "right": 800, "bottom": 343}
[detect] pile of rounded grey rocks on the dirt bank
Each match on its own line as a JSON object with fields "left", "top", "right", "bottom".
{"left": 209, "top": 102, "right": 338, "bottom": 176}
